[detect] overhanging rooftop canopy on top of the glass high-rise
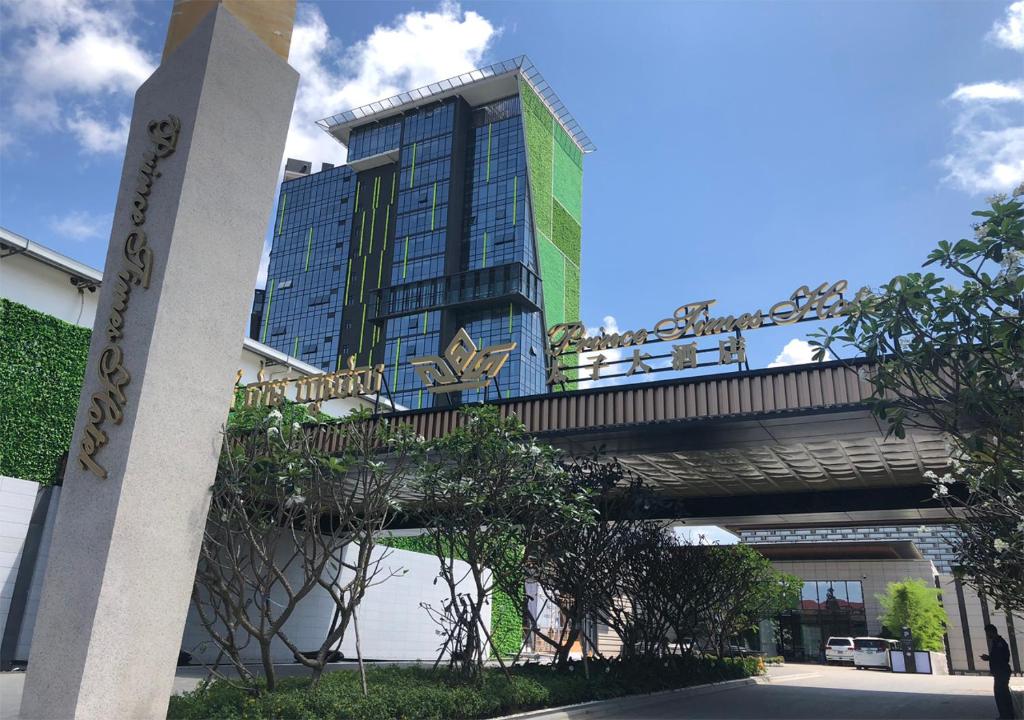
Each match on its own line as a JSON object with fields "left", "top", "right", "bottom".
{"left": 316, "top": 55, "right": 597, "bottom": 154}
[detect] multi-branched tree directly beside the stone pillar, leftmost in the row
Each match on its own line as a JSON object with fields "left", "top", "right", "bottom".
{"left": 193, "top": 406, "right": 415, "bottom": 691}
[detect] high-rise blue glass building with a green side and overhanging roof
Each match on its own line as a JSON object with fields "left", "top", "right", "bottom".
{"left": 252, "top": 57, "right": 594, "bottom": 408}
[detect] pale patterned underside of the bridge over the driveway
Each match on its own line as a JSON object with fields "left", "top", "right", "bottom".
{"left": 540, "top": 409, "right": 949, "bottom": 526}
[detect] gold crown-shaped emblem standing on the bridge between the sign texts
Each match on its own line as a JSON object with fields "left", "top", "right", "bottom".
{"left": 410, "top": 328, "right": 516, "bottom": 392}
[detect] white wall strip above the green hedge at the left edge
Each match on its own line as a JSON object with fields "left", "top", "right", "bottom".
{"left": 0, "top": 253, "right": 99, "bottom": 328}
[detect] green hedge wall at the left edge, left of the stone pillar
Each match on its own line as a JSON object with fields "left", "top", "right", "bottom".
{"left": 0, "top": 298, "right": 91, "bottom": 484}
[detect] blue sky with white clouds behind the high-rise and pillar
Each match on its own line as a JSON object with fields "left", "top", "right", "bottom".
{"left": 0, "top": 0, "right": 1024, "bottom": 367}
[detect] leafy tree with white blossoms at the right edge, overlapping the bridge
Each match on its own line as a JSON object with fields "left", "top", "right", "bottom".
{"left": 812, "top": 185, "right": 1024, "bottom": 610}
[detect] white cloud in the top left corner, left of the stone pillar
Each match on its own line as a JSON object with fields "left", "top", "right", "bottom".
{"left": 0, "top": 0, "right": 156, "bottom": 153}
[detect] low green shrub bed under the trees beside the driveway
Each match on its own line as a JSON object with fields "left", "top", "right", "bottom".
{"left": 168, "top": 658, "right": 758, "bottom": 720}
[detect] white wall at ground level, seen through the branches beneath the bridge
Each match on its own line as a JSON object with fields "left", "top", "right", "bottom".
{"left": 181, "top": 546, "right": 490, "bottom": 663}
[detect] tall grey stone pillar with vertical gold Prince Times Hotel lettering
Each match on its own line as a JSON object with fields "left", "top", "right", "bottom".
{"left": 22, "top": 0, "right": 298, "bottom": 718}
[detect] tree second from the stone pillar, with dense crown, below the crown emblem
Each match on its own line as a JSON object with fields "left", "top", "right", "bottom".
{"left": 410, "top": 406, "right": 591, "bottom": 679}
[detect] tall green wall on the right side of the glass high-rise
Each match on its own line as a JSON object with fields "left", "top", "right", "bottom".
{"left": 519, "top": 80, "right": 583, "bottom": 342}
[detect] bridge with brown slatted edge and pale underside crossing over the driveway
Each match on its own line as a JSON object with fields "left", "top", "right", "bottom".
{"left": 316, "top": 362, "right": 949, "bottom": 525}
